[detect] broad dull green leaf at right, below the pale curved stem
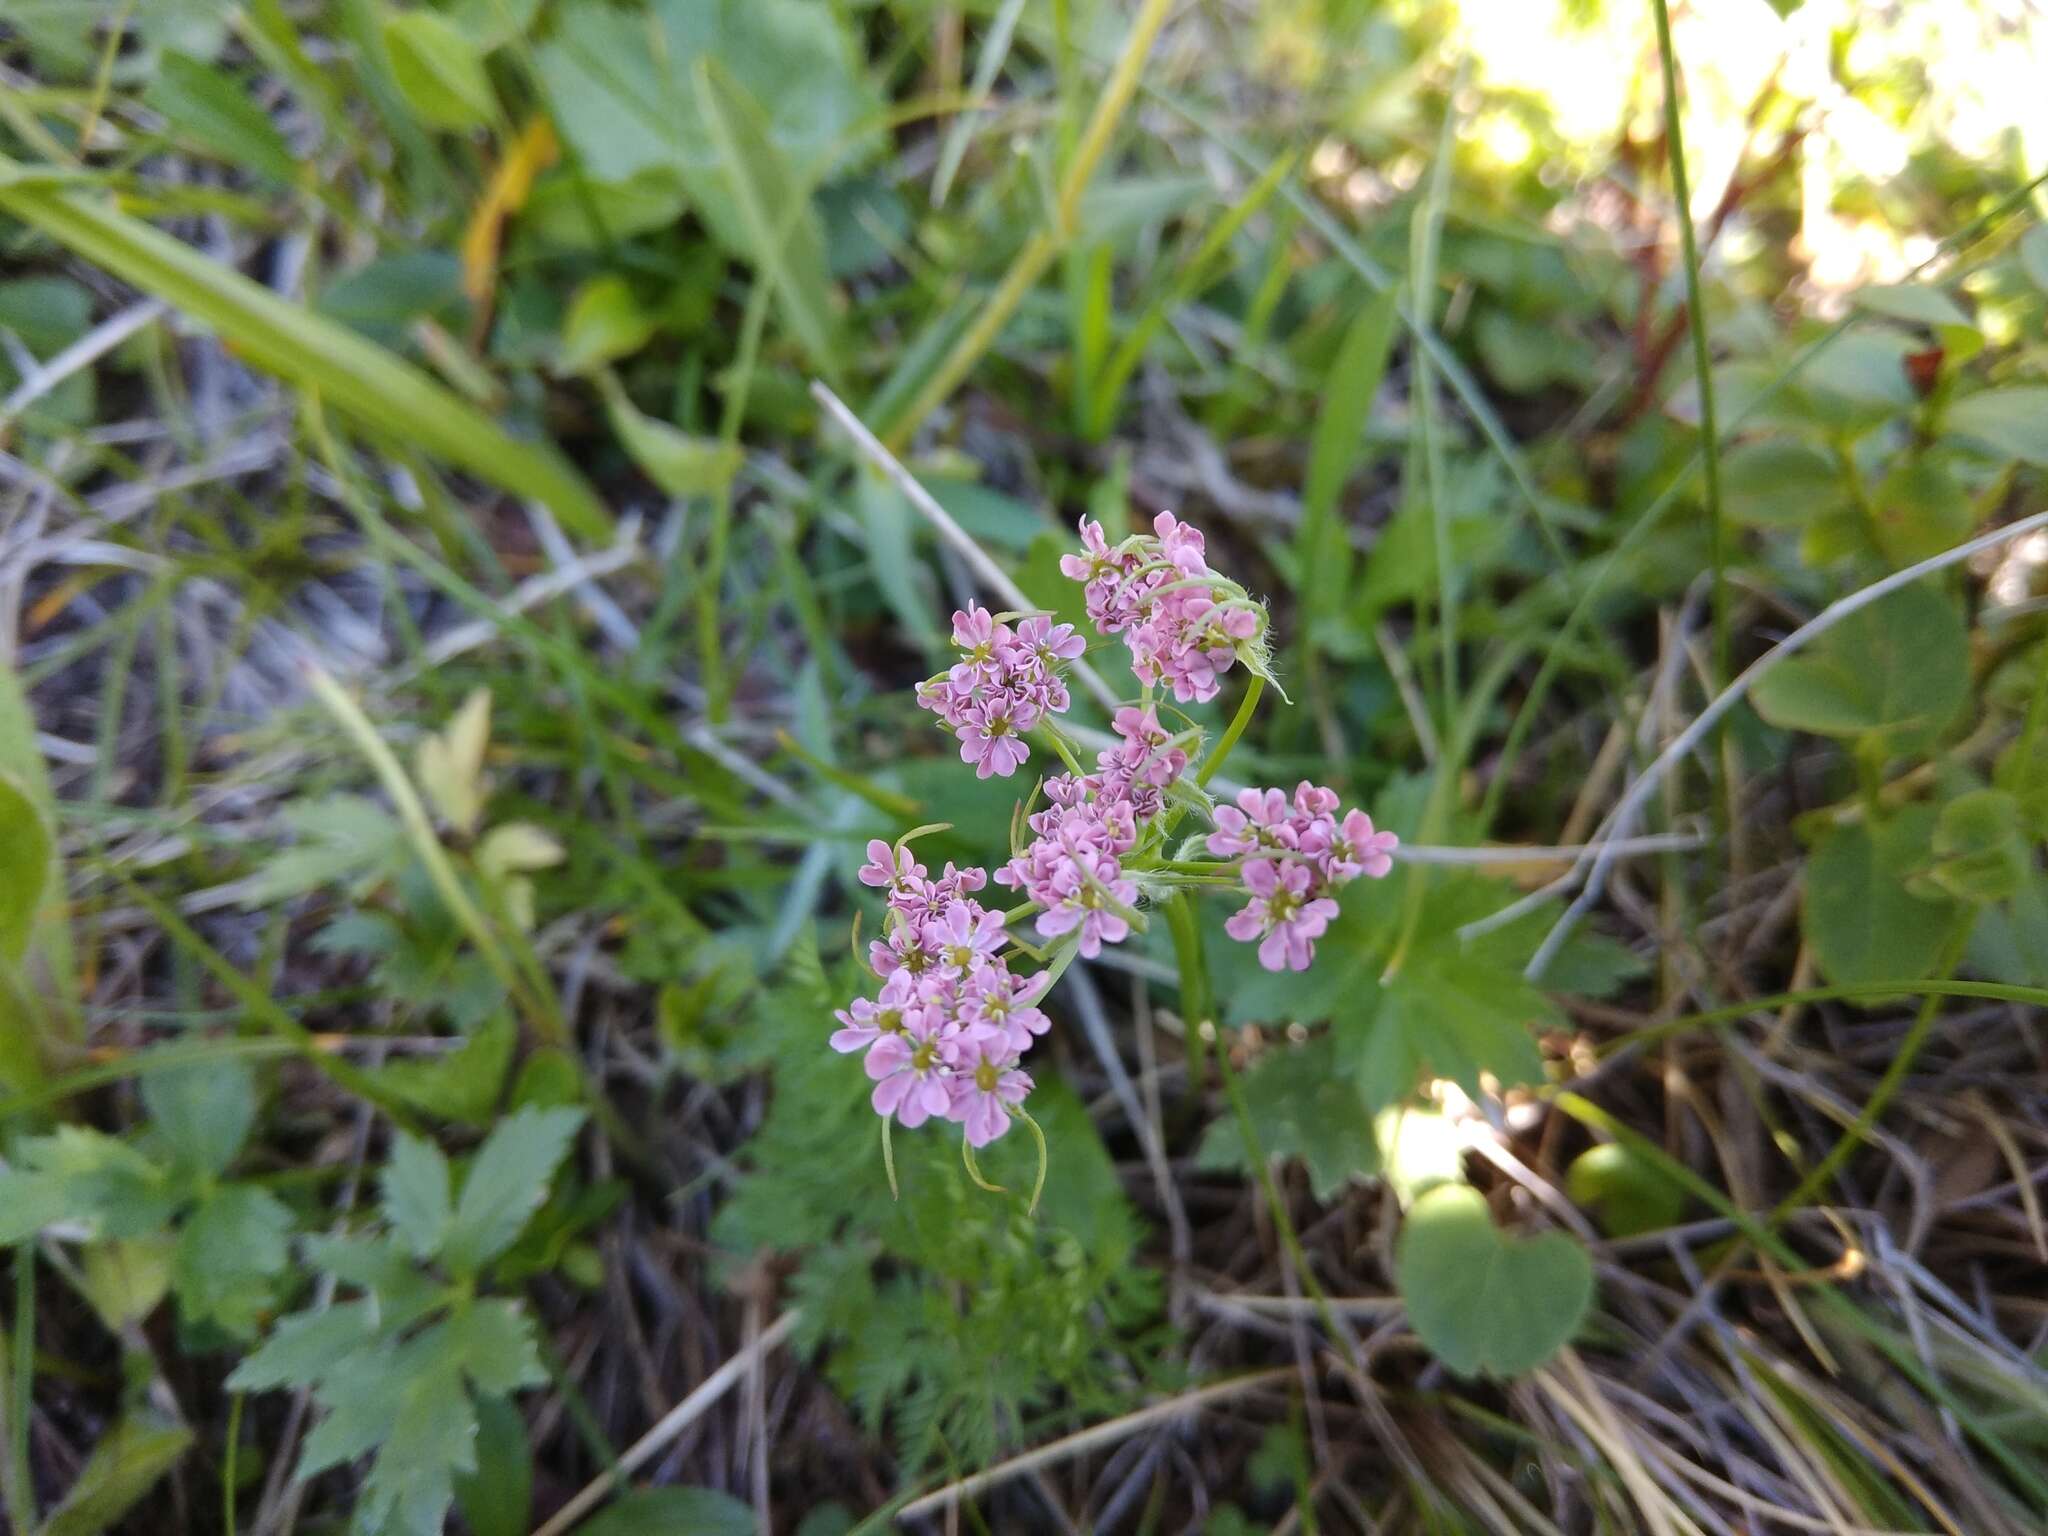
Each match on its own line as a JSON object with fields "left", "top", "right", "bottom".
{"left": 1804, "top": 805, "right": 1960, "bottom": 983}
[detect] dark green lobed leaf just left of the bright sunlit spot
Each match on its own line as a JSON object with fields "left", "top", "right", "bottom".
{"left": 1194, "top": 1034, "right": 1380, "bottom": 1200}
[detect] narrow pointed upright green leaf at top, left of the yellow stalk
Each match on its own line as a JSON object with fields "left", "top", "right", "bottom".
{"left": 696, "top": 55, "right": 844, "bottom": 381}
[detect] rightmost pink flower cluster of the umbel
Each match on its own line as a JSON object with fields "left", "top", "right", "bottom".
{"left": 1208, "top": 778, "right": 1401, "bottom": 971}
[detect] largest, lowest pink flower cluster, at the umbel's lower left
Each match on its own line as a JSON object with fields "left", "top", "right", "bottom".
{"left": 831, "top": 838, "right": 1053, "bottom": 1147}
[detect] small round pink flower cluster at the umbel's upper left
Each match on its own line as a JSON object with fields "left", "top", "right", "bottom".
{"left": 918, "top": 602, "right": 1087, "bottom": 778}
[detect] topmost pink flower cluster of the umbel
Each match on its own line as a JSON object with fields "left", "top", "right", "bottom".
{"left": 1059, "top": 512, "right": 1266, "bottom": 705}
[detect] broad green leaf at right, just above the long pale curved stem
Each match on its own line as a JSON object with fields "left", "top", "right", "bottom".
{"left": 1751, "top": 586, "right": 1970, "bottom": 752}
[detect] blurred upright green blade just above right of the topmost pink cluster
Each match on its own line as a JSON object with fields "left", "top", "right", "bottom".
{"left": 1294, "top": 287, "right": 1401, "bottom": 643}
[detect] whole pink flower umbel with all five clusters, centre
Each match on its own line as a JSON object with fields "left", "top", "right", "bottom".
{"left": 831, "top": 512, "right": 1399, "bottom": 1178}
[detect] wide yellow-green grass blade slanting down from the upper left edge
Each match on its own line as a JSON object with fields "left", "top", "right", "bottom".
{"left": 0, "top": 160, "right": 610, "bottom": 539}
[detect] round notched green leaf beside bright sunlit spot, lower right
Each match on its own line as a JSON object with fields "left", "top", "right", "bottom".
{"left": 1395, "top": 1186, "right": 1593, "bottom": 1378}
